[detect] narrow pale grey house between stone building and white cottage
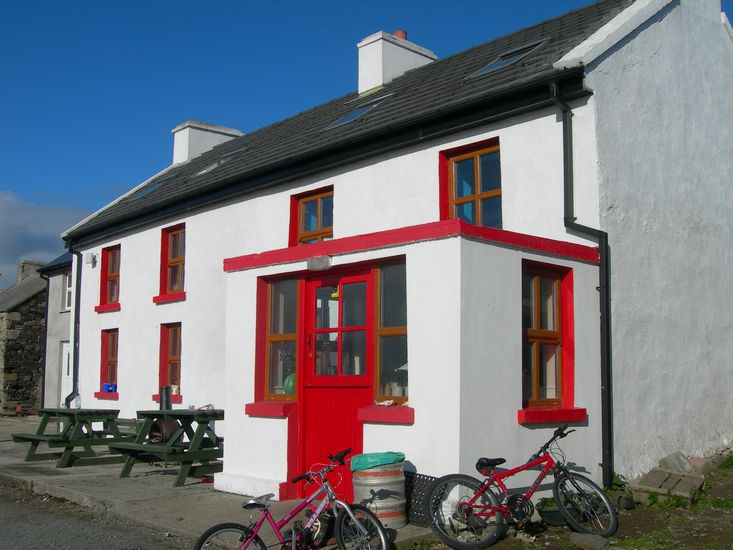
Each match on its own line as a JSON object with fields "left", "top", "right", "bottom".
{"left": 38, "top": 252, "right": 74, "bottom": 408}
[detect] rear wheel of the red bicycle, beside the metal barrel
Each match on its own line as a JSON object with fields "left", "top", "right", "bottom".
{"left": 426, "top": 474, "right": 504, "bottom": 550}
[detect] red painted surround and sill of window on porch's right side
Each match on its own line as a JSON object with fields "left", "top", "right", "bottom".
{"left": 517, "top": 260, "right": 588, "bottom": 424}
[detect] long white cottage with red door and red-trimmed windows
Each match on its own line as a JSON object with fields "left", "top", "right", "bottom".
{"left": 58, "top": 0, "right": 733, "bottom": 498}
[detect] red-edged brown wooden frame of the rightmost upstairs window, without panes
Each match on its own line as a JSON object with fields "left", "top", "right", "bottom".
{"left": 438, "top": 138, "right": 504, "bottom": 229}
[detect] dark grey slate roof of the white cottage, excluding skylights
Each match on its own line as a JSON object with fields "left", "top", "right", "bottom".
{"left": 66, "top": 0, "right": 633, "bottom": 241}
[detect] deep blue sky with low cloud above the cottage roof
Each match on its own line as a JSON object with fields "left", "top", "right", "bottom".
{"left": 0, "top": 0, "right": 733, "bottom": 288}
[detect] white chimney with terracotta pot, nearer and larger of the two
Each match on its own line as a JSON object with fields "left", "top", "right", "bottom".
{"left": 356, "top": 31, "right": 438, "bottom": 94}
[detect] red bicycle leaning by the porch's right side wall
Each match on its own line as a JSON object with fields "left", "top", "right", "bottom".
{"left": 427, "top": 426, "right": 618, "bottom": 550}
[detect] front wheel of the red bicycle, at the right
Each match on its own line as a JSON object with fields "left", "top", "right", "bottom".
{"left": 552, "top": 472, "right": 618, "bottom": 537}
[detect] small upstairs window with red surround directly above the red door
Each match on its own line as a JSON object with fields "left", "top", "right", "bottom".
{"left": 290, "top": 187, "right": 333, "bottom": 246}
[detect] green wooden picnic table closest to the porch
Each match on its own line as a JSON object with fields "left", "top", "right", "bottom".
{"left": 109, "top": 409, "right": 224, "bottom": 487}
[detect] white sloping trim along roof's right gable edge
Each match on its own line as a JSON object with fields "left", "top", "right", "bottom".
{"left": 553, "top": 0, "right": 673, "bottom": 69}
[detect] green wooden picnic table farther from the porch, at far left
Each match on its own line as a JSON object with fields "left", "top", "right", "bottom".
{"left": 12, "top": 409, "right": 134, "bottom": 468}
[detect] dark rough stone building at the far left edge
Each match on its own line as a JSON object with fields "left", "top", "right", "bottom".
{"left": 0, "top": 261, "right": 46, "bottom": 412}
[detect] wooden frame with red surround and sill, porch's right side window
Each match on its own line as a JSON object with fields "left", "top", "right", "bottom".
{"left": 517, "top": 260, "right": 588, "bottom": 425}
